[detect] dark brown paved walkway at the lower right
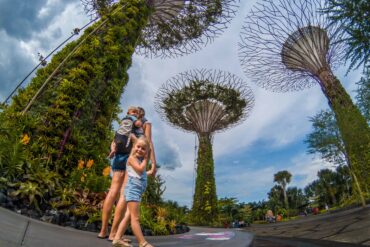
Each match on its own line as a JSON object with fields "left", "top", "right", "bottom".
{"left": 245, "top": 205, "right": 370, "bottom": 246}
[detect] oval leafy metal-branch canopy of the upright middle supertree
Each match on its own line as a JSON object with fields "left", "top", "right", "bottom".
{"left": 155, "top": 69, "right": 254, "bottom": 135}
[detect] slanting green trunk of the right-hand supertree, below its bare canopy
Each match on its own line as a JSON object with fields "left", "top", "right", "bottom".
{"left": 319, "top": 69, "right": 370, "bottom": 194}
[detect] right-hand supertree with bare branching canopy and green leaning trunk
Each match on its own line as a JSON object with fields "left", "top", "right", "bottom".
{"left": 239, "top": 0, "right": 370, "bottom": 202}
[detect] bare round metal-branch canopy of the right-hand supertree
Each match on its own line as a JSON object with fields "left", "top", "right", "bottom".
{"left": 239, "top": 0, "right": 345, "bottom": 92}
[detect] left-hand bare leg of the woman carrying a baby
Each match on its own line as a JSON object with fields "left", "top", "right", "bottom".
{"left": 98, "top": 171, "right": 125, "bottom": 237}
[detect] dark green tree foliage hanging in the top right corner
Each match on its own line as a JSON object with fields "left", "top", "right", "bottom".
{"left": 322, "top": 0, "right": 370, "bottom": 70}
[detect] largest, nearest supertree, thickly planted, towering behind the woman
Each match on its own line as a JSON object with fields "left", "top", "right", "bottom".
{"left": 3, "top": 0, "right": 237, "bottom": 174}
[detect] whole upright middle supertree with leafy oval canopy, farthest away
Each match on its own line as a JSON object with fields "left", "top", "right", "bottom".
{"left": 155, "top": 69, "right": 254, "bottom": 225}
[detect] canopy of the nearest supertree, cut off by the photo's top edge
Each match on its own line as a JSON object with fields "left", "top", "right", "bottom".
{"left": 81, "top": 0, "right": 239, "bottom": 58}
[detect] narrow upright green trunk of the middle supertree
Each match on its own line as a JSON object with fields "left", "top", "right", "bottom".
{"left": 192, "top": 134, "right": 218, "bottom": 225}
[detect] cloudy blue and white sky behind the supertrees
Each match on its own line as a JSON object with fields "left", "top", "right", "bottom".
{"left": 0, "top": 0, "right": 361, "bottom": 207}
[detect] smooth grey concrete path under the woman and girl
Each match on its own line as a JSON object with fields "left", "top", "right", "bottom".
{"left": 0, "top": 208, "right": 253, "bottom": 247}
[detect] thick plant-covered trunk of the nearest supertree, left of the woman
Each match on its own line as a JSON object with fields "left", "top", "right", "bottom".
{"left": 4, "top": 0, "right": 150, "bottom": 175}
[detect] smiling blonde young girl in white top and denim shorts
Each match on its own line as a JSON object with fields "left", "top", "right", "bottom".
{"left": 113, "top": 136, "right": 153, "bottom": 247}
